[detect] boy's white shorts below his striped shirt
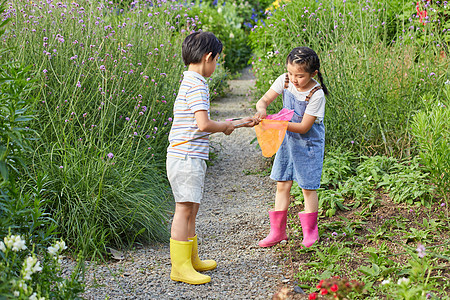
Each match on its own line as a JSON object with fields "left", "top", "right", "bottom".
{"left": 166, "top": 156, "right": 206, "bottom": 203}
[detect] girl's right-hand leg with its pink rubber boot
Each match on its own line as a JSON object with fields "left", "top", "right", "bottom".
{"left": 298, "top": 189, "right": 319, "bottom": 248}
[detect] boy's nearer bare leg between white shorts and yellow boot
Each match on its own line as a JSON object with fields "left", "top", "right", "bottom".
{"left": 170, "top": 202, "right": 195, "bottom": 242}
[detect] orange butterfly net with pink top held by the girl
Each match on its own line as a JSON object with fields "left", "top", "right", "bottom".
{"left": 254, "top": 108, "right": 294, "bottom": 157}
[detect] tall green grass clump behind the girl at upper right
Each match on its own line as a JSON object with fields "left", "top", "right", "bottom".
{"left": 250, "top": 0, "right": 449, "bottom": 157}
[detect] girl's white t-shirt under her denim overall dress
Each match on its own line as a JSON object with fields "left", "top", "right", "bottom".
{"left": 270, "top": 73, "right": 326, "bottom": 122}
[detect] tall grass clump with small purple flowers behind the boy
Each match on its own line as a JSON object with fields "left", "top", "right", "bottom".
{"left": 3, "top": 1, "right": 227, "bottom": 256}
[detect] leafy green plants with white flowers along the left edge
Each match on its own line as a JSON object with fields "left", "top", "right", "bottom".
{"left": 0, "top": 3, "right": 83, "bottom": 299}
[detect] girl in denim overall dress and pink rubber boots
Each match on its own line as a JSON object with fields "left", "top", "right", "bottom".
{"left": 255, "top": 47, "right": 328, "bottom": 247}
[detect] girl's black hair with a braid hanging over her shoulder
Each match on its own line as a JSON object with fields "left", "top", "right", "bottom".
{"left": 286, "top": 47, "right": 328, "bottom": 95}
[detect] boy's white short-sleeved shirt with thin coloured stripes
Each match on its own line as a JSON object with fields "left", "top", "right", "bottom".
{"left": 167, "top": 71, "right": 209, "bottom": 160}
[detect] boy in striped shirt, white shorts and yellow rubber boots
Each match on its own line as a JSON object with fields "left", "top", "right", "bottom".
{"left": 166, "top": 31, "right": 257, "bottom": 284}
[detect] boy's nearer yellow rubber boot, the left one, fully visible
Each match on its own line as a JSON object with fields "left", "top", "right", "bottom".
{"left": 170, "top": 239, "right": 211, "bottom": 284}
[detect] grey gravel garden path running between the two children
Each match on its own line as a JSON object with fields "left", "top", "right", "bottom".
{"left": 67, "top": 73, "right": 285, "bottom": 299}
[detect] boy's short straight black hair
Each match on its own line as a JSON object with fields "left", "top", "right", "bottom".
{"left": 181, "top": 31, "right": 223, "bottom": 66}
